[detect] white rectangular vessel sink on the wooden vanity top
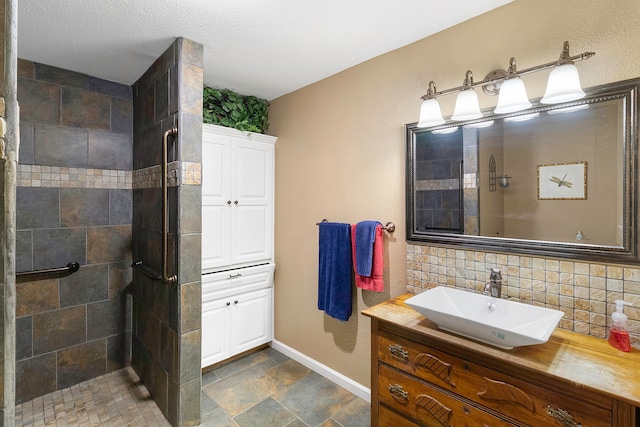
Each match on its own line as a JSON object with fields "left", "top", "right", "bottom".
{"left": 405, "top": 286, "right": 564, "bottom": 349}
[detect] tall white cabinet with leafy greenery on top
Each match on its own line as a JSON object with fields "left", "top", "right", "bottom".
{"left": 202, "top": 124, "right": 277, "bottom": 367}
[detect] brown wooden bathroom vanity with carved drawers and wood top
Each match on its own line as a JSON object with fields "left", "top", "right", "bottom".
{"left": 362, "top": 294, "right": 640, "bottom": 427}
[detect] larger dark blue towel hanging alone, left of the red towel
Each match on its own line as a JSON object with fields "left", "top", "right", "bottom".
{"left": 318, "top": 222, "right": 352, "bottom": 321}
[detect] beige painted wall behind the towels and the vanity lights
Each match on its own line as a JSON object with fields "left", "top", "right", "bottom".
{"left": 269, "top": 0, "right": 640, "bottom": 386}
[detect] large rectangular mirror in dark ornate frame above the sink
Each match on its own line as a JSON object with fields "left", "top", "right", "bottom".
{"left": 405, "top": 79, "right": 640, "bottom": 262}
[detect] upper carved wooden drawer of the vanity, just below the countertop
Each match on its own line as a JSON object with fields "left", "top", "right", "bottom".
{"left": 378, "top": 331, "right": 612, "bottom": 426}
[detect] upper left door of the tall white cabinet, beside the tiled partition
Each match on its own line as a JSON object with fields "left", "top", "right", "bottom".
{"left": 202, "top": 131, "right": 232, "bottom": 271}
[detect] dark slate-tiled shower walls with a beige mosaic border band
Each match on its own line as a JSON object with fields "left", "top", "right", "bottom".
{"left": 16, "top": 38, "right": 203, "bottom": 425}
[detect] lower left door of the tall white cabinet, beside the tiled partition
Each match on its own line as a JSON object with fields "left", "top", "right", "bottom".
{"left": 201, "top": 298, "right": 231, "bottom": 368}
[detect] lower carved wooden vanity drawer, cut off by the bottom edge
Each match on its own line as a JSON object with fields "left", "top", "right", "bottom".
{"left": 378, "top": 363, "right": 514, "bottom": 427}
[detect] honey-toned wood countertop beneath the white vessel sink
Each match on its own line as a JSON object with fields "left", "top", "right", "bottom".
{"left": 362, "top": 294, "right": 640, "bottom": 407}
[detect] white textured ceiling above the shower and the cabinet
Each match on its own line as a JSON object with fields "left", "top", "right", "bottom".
{"left": 18, "top": 0, "right": 512, "bottom": 100}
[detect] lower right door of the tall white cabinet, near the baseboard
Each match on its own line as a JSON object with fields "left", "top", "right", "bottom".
{"left": 231, "top": 289, "right": 273, "bottom": 354}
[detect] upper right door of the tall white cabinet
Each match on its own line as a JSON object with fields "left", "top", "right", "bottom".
{"left": 231, "top": 140, "right": 273, "bottom": 264}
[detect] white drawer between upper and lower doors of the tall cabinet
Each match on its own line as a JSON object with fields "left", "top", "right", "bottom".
{"left": 202, "top": 264, "right": 275, "bottom": 302}
